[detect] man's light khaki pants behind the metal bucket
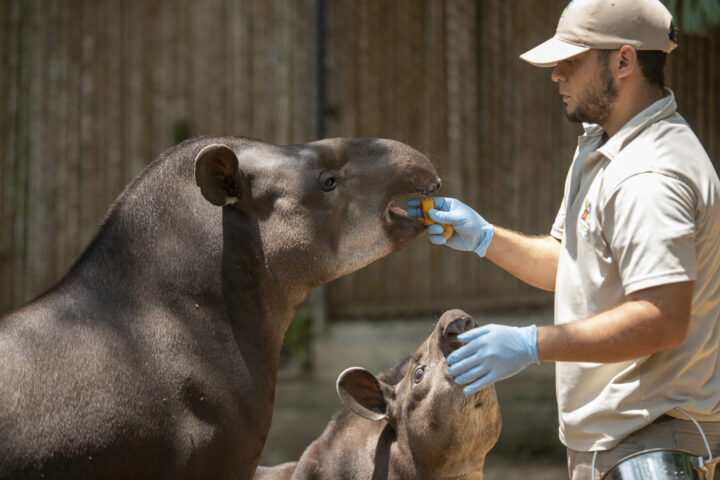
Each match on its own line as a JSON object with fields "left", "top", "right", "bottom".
{"left": 567, "top": 416, "right": 720, "bottom": 480}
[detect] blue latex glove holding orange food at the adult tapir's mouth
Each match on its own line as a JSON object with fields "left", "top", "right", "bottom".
{"left": 405, "top": 197, "right": 494, "bottom": 257}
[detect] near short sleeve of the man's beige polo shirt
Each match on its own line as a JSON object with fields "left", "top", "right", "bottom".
{"left": 602, "top": 171, "right": 696, "bottom": 295}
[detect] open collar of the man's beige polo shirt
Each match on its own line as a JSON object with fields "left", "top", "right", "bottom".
{"left": 583, "top": 88, "right": 677, "bottom": 160}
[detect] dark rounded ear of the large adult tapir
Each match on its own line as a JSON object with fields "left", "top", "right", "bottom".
{"left": 195, "top": 143, "right": 248, "bottom": 206}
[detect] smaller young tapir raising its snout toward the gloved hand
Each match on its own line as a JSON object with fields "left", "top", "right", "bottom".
{"left": 254, "top": 310, "right": 502, "bottom": 480}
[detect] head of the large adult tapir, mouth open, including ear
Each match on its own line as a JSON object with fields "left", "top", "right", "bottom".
{"left": 195, "top": 138, "right": 440, "bottom": 287}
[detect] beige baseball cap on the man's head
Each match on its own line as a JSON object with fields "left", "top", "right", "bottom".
{"left": 520, "top": 0, "right": 677, "bottom": 67}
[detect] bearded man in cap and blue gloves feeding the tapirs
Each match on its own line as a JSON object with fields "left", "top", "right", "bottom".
{"left": 408, "top": 0, "right": 720, "bottom": 480}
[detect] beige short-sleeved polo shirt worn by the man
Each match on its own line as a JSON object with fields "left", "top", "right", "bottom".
{"left": 551, "top": 90, "right": 720, "bottom": 451}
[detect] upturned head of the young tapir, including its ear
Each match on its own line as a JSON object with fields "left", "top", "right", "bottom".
{"left": 337, "top": 310, "right": 501, "bottom": 478}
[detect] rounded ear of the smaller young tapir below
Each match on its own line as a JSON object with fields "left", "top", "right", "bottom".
{"left": 336, "top": 367, "right": 395, "bottom": 420}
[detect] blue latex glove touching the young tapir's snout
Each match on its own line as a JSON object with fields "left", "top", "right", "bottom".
{"left": 447, "top": 324, "right": 540, "bottom": 395}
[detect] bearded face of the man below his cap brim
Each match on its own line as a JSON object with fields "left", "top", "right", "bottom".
{"left": 551, "top": 50, "right": 617, "bottom": 126}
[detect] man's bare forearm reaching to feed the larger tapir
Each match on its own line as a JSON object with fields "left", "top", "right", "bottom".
{"left": 485, "top": 226, "right": 560, "bottom": 292}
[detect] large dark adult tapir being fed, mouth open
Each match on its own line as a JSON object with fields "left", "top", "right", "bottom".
{"left": 0, "top": 137, "right": 440, "bottom": 480}
